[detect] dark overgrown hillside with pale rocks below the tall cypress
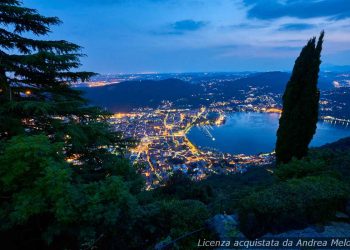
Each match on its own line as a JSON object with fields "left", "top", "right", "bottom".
{"left": 197, "top": 137, "right": 350, "bottom": 238}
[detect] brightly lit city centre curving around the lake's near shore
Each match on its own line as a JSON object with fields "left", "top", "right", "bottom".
{"left": 111, "top": 108, "right": 273, "bottom": 188}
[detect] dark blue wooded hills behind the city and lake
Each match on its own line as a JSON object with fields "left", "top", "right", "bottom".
{"left": 80, "top": 72, "right": 344, "bottom": 112}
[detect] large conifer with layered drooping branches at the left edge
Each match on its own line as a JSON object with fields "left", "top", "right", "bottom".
{"left": 0, "top": 0, "right": 134, "bottom": 180}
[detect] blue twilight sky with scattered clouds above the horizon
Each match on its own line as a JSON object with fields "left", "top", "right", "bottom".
{"left": 23, "top": 0, "right": 350, "bottom": 73}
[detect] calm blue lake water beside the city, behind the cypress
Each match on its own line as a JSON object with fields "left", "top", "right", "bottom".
{"left": 187, "top": 113, "right": 350, "bottom": 154}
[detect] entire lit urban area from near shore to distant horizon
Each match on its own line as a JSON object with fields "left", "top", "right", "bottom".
{"left": 86, "top": 71, "right": 350, "bottom": 189}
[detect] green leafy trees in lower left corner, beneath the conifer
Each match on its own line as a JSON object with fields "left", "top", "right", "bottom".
{"left": 0, "top": 135, "right": 137, "bottom": 247}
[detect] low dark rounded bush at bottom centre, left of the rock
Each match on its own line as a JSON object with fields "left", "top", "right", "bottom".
{"left": 135, "top": 200, "right": 210, "bottom": 249}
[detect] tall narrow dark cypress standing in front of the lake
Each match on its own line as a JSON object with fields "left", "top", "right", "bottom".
{"left": 276, "top": 31, "right": 324, "bottom": 164}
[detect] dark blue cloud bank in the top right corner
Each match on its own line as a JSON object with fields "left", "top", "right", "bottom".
{"left": 243, "top": 0, "right": 350, "bottom": 20}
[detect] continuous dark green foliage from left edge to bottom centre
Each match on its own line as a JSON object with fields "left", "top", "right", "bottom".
{"left": 0, "top": 135, "right": 209, "bottom": 249}
